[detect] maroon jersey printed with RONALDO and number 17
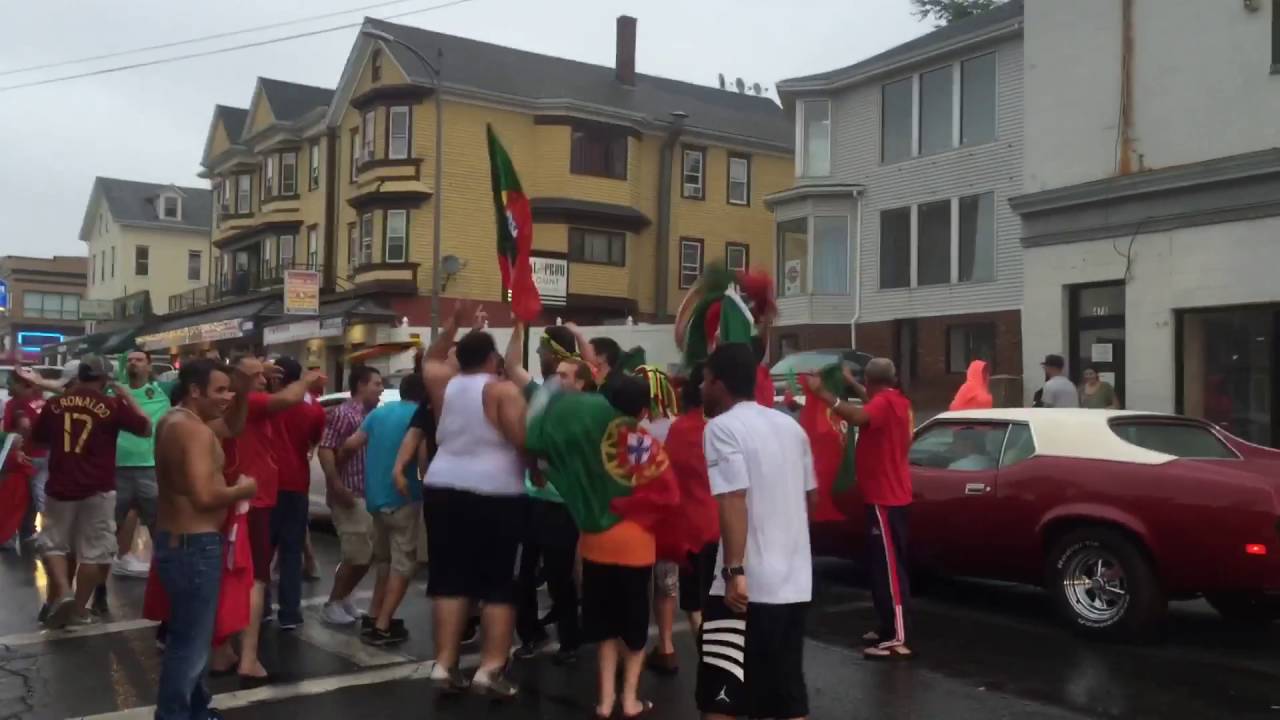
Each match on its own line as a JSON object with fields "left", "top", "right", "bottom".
{"left": 33, "top": 388, "right": 151, "bottom": 501}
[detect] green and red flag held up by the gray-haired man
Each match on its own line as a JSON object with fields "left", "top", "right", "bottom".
{"left": 797, "top": 364, "right": 856, "bottom": 521}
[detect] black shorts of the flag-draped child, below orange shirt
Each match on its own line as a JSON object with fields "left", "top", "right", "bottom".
{"left": 582, "top": 560, "right": 653, "bottom": 652}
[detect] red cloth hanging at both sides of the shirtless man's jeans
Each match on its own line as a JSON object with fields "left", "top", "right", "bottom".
{"left": 142, "top": 499, "right": 253, "bottom": 647}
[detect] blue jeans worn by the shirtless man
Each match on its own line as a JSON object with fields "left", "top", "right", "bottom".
{"left": 154, "top": 532, "right": 223, "bottom": 720}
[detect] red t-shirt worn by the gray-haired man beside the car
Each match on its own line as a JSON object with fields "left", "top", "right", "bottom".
{"left": 854, "top": 389, "right": 911, "bottom": 507}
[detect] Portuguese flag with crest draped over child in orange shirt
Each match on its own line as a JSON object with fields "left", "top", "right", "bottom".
{"left": 525, "top": 387, "right": 700, "bottom": 562}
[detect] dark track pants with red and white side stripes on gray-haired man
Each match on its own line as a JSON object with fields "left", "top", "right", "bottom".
{"left": 867, "top": 505, "right": 911, "bottom": 647}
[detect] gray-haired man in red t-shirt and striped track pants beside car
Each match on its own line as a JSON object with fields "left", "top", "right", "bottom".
{"left": 809, "top": 357, "right": 915, "bottom": 660}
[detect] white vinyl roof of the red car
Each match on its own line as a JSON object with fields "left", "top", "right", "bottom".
{"left": 929, "top": 407, "right": 1184, "bottom": 465}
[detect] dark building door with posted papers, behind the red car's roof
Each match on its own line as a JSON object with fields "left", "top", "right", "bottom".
{"left": 1064, "top": 282, "right": 1125, "bottom": 406}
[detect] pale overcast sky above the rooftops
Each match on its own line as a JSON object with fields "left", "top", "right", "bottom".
{"left": 0, "top": 0, "right": 931, "bottom": 256}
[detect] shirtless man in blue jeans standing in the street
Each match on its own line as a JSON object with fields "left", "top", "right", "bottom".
{"left": 155, "top": 359, "right": 257, "bottom": 720}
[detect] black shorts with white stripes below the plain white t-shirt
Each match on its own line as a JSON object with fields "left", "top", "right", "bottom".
{"left": 696, "top": 596, "right": 809, "bottom": 717}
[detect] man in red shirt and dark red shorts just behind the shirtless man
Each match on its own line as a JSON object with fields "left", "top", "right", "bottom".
{"left": 220, "top": 355, "right": 316, "bottom": 682}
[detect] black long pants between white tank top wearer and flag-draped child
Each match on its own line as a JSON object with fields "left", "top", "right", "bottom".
{"left": 516, "top": 498, "right": 582, "bottom": 650}
